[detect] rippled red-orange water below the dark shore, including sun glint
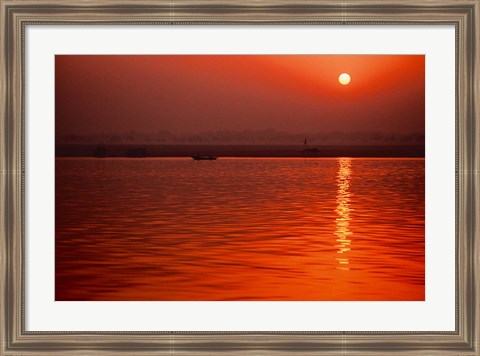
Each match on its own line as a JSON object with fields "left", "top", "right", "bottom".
{"left": 55, "top": 158, "right": 425, "bottom": 300}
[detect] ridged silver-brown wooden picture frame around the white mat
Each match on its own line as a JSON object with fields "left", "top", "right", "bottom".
{"left": 0, "top": 0, "right": 480, "bottom": 355}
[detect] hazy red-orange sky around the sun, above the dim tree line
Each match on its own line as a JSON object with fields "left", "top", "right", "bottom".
{"left": 55, "top": 55, "right": 425, "bottom": 135}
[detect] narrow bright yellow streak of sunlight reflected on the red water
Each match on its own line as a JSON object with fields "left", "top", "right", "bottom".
{"left": 335, "top": 158, "right": 352, "bottom": 270}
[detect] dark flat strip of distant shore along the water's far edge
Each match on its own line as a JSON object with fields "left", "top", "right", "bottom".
{"left": 55, "top": 144, "right": 425, "bottom": 158}
